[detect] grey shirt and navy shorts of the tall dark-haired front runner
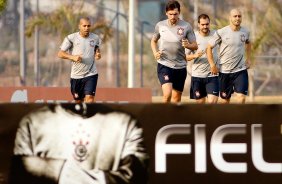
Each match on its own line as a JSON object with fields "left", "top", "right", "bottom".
{"left": 153, "top": 19, "right": 196, "bottom": 92}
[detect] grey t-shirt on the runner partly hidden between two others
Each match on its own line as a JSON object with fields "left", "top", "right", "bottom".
{"left": 186, "top": 30, "right": 218, "bottom": 78}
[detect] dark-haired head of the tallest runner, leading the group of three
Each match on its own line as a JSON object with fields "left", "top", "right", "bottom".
{"left": 165, "top": 0, "right": 180, "bottom": 24}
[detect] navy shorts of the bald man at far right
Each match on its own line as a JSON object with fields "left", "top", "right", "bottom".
{"left": 219, "top": 70, "right": 249, "bottom": 99}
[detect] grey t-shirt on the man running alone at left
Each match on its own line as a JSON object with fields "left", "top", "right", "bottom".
{"left": 60, "top": 32, "right": 101, "bottom": 79}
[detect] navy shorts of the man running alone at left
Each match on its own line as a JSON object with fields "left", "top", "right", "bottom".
{"left": 70, "top": 74, "right": 98, "bottom": 100}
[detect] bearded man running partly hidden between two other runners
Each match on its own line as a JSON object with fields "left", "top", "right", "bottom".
{"left": 186, "top": 14, "right": 219, "bottom": 104}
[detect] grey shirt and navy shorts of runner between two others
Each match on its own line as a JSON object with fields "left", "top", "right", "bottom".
{"left": 186, "top": 30, "right": 219, "bottom": 99}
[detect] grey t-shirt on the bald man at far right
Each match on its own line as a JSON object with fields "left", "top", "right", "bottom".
{"left": 209, "top": 26, "right": 250, "bottom": 73}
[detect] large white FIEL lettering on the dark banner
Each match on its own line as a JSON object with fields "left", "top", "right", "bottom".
{"left": 155, "top": 124, "right": 282, "bottom": 173}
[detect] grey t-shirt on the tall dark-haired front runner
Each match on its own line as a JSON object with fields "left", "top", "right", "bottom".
{"left": 153, "top": 19, "right": 196, "bottom": 69}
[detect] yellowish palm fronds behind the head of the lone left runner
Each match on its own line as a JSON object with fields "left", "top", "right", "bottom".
{"left": 25, "top": 1, "right": 112, "bottom": 42}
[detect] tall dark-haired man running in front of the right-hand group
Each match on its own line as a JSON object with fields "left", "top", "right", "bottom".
{"left": 151, "top": 1, "right": 198, "bottom": 102}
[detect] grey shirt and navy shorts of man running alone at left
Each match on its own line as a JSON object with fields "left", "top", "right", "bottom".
{"left": 60, "top": 32, "right": 101, "bottom": 100}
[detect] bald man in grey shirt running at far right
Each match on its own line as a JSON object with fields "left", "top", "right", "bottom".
{"left": 207, "top": 9, "right": 251, "bottom": 103}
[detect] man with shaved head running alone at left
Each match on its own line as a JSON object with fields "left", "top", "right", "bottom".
{"left": 58, "top": 18, "right": 101, "bottom": 103}
